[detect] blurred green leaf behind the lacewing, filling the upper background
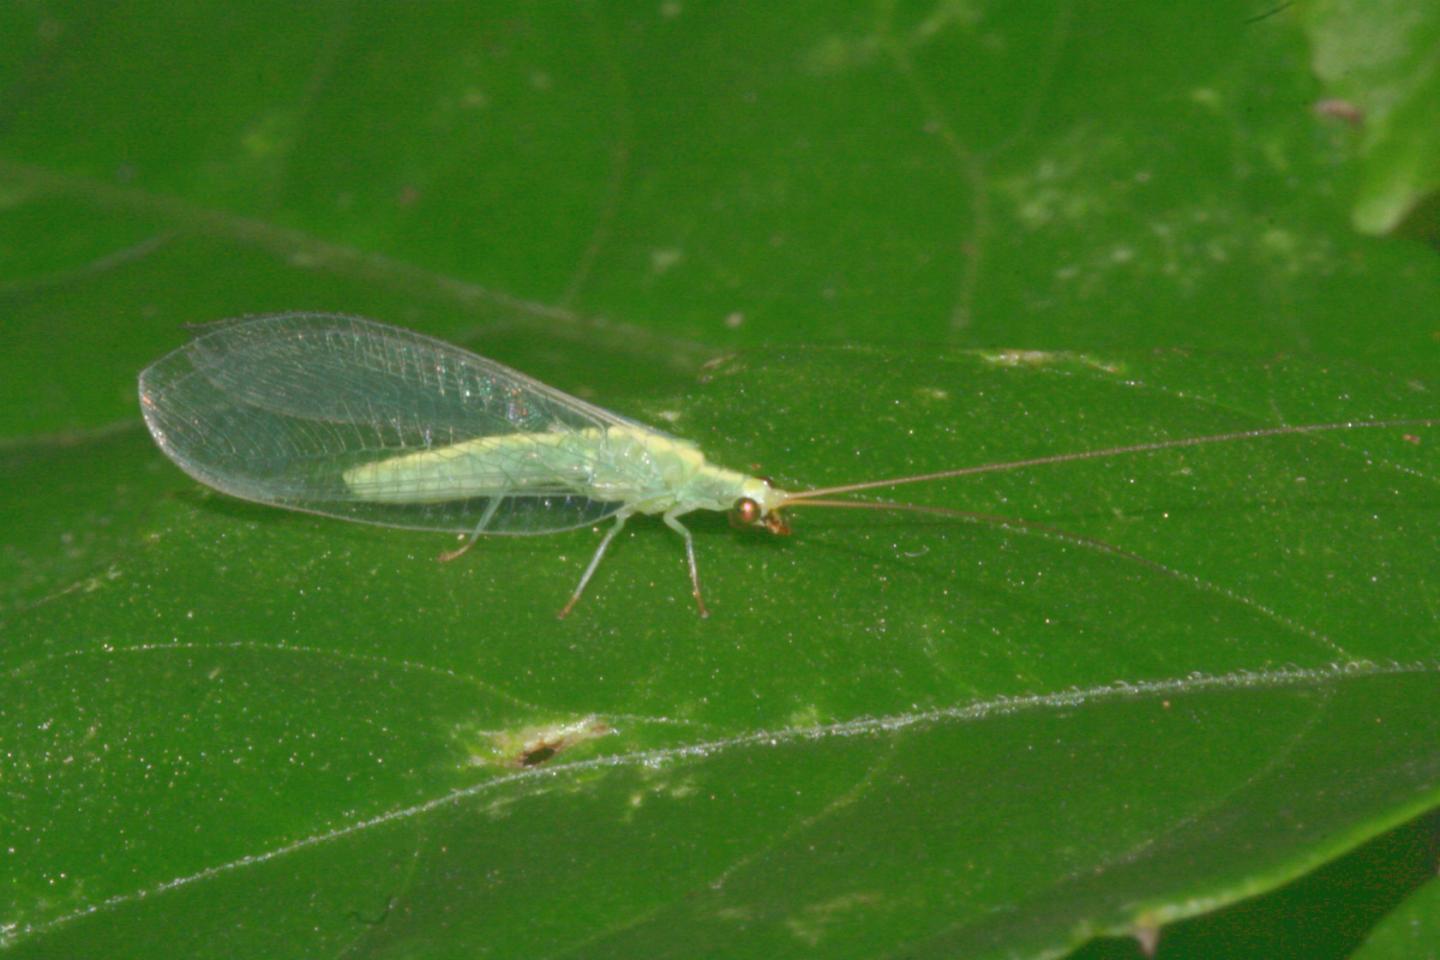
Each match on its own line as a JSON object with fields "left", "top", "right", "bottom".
{"left": 0, "top": 0, "right": 1440, "bottom": 436}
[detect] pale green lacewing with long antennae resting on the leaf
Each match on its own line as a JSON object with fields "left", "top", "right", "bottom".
{"left": 140, "top": 312, "right": 1437, "bottom": 616}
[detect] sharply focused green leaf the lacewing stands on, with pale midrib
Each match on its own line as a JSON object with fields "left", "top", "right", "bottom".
{"left": 0, "top": 343, "right": 1440, "bottom": 956}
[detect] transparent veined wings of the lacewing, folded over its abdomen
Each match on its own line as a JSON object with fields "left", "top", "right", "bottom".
{"left": 140, "top": 314, "right": 658, "bottom": 534}
